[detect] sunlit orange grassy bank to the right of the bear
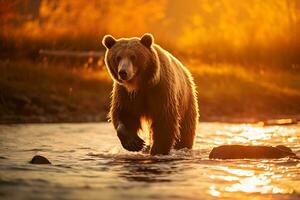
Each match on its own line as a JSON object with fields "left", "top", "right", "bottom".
{"left": 190, "top": 63, "right": 300, "bottom": 122}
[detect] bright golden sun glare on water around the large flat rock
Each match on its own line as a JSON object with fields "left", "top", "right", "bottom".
{"left": 199, "top": 124, "right": 300, "bottom": 197}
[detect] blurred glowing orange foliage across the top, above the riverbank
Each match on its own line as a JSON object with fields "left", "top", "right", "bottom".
{"left": 0, "top": 0, "right": 300, "bottom": 67}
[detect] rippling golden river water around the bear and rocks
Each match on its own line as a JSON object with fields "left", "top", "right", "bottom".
{"left": 0, "top": 123, "right": 300, "bottom": 200}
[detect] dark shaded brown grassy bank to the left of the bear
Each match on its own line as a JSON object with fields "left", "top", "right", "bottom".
{"left": 0, "top": 60, "right": 111, "bottom": 123}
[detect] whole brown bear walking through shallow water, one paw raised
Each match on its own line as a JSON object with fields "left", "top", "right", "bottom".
{"left": 102, "top": 33, "right": 198, "bottom": 155}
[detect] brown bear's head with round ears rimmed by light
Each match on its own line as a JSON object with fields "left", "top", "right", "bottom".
{"left": 102, "top": 33, "right": 159, "bottom": 91}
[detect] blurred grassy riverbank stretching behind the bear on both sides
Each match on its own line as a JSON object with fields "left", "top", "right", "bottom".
{"left": 0, "top": 60, "right": 300, "bottom": 123}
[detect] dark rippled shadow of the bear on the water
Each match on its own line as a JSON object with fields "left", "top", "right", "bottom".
{"left": 89, "top": 150, "right": 202, "bottom": 183}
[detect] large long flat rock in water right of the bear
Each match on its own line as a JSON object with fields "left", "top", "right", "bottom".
{"left": 209, "top": 145, "right": 297, "bottom": 159}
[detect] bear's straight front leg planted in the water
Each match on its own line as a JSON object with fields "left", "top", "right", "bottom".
{"left": 150, "top": 116, "right": 179, "bottom": 155}
